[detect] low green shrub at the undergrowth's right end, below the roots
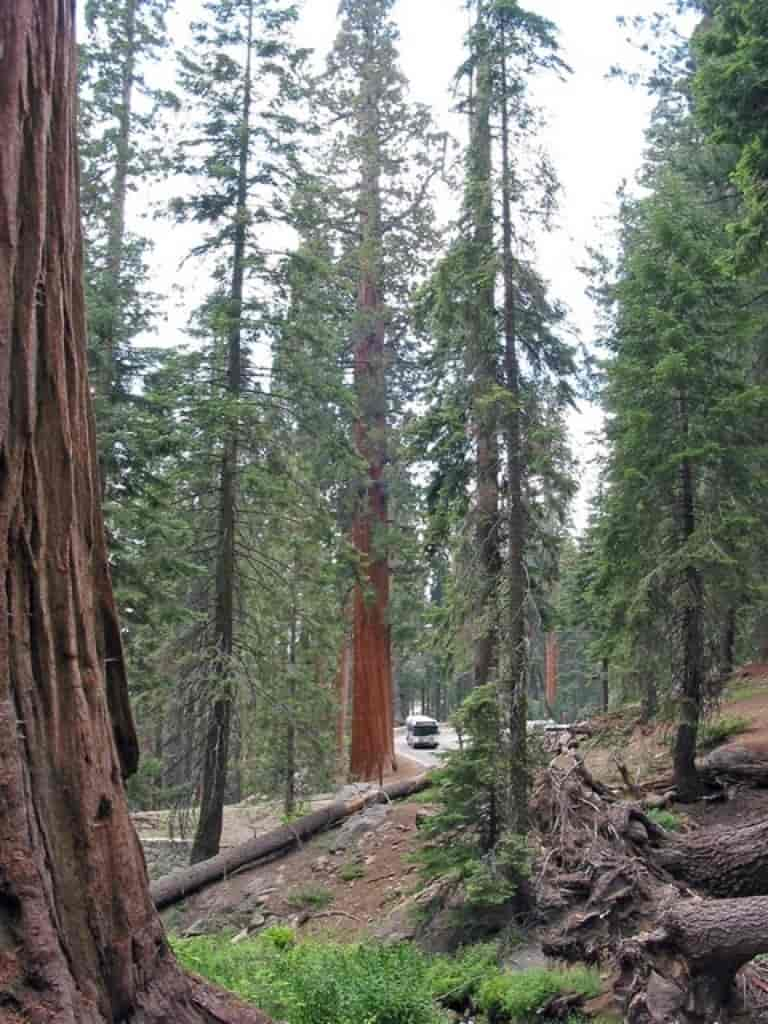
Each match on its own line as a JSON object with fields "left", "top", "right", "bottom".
{"left": 477, "top": 968, "right": 600, "bottom": 1024}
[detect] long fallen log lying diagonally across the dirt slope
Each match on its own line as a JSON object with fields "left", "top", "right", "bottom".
{"left": 150, "top": 773, "right": 429, "bottom": 910}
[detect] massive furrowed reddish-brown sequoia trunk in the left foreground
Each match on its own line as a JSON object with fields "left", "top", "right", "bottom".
{"left": 0, "top": 0, "right": 264, "bottom": 1024}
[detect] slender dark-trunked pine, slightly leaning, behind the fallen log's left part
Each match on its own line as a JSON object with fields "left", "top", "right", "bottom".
{"left": 174, "top": 0, "right": 309, "bottom": 861}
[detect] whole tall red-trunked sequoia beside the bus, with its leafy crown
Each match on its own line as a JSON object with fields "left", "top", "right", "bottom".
{"left": 318, "top": 0, "right": 440, "bottom": 778}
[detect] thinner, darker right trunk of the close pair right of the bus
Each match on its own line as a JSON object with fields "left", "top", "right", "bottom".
{"left": 501, "top": 19, "right": 530, "bottom": 834}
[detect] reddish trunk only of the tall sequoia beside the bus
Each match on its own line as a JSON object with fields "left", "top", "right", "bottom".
{"left": 349, "top": 10, "right": 394, "bottom": 779}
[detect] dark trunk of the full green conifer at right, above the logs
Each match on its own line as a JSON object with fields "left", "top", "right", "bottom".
{"left": 673, "top": 392, "right": 703, "bottom": 800}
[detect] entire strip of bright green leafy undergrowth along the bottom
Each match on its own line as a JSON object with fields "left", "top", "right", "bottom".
{"left": 173, "top": 928, "right": 600, "bottom": 1024}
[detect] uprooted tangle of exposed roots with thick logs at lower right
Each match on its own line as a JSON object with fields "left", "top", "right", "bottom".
{"left": 531, "top": 754, "right": 768, "bottom": 1024}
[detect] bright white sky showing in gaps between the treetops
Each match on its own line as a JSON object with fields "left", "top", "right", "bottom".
{"left": 79, "top": 0, "right": 679, "bottom": 526}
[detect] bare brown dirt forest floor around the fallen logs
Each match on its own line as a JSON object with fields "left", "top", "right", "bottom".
{"left": 136, "top": 665, "right": 768, "bottom": 970}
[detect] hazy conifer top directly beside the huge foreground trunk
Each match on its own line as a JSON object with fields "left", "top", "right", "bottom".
{"left": 79, "top": 0, "right": 175, "bottom": 491}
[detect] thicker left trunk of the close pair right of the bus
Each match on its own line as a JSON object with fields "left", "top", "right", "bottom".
{"left": 468, "top": 0, "right": 502, "bottom": 686}
